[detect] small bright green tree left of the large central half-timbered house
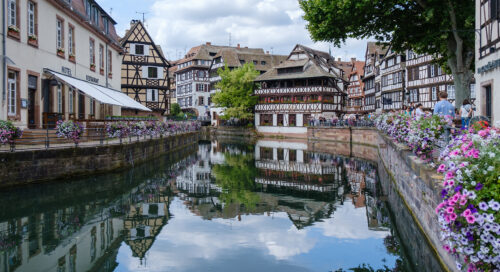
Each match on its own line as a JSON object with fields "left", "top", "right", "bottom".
{"left": 212, "top": 63, "right": 260, "bottom": 120}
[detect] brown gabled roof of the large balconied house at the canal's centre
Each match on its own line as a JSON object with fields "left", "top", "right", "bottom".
{"left": 255, "top": 44, "right": 343, "bottom": 81}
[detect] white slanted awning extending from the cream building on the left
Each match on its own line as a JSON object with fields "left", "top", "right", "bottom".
{"left": 45, "top": 69, "right": 151, "bottom": 111}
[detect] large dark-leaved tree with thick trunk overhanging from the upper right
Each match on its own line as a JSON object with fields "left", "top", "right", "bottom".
{"left": 299, "top": 0, "right": 475, "bottom": 106}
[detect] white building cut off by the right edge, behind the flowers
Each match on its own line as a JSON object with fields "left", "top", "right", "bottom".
{"left": 475, "top": 0, "right": 500, "bottom": 122}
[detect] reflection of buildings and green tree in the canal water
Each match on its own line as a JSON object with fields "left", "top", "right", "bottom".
{"left": 0, "top": 140, "right": 398, "bottom": 272}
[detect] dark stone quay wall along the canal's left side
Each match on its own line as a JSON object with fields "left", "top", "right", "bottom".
{"left": 0, "top": 132, "right": 200, "bottom": 188}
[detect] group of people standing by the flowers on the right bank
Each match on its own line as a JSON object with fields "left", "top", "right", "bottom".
{"left": 394, "top": 92, "right": 474, "bottom": 129}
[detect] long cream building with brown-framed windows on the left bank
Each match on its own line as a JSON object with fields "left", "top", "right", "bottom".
{"left": 0, "top": 0, "right": 142, "bottom": 128}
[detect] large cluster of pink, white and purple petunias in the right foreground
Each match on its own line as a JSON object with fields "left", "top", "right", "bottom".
{"left": 436, "top": 128, "right": 500, "bottom": 271}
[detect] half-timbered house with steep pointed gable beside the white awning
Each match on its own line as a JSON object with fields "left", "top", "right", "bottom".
{"left": 120, "top": 20, "right": 170, "bottom": 117}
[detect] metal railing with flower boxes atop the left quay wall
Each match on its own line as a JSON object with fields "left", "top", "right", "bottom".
{"left": 0, "top": 120, "right": 199, "bottom": 153}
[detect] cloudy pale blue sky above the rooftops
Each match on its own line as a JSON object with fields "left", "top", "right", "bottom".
{"left": 97, "top": 0, "right": 372, "bottom": 60}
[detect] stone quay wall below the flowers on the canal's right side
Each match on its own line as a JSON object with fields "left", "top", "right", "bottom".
{"left": 308, "top": 128, "right": 456, "bottom": 271}
